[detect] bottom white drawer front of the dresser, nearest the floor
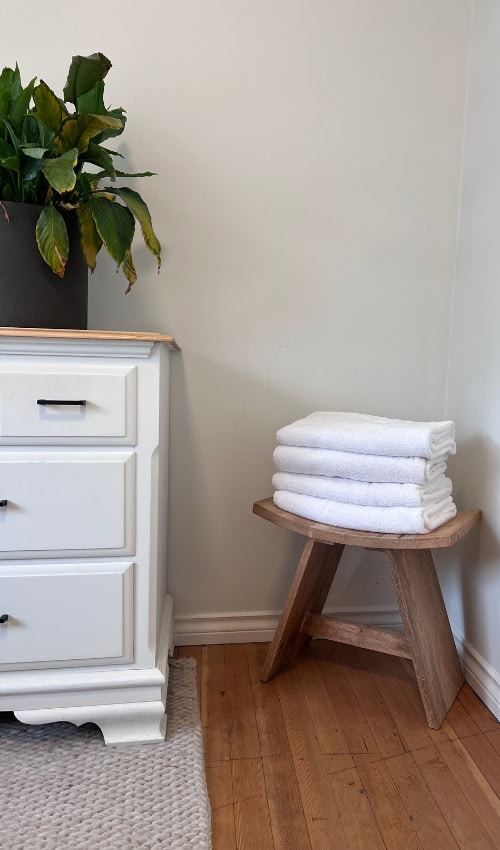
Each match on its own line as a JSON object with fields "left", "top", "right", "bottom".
{"left": 0, "top": 563, "right": 133, "bottom": 669}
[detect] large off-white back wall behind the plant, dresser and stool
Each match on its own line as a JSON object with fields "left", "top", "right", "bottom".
{"left": 2, "top": 0, "right": 470, "bottom": 640}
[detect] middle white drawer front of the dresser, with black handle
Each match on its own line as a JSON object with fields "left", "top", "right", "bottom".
{"left": 0, "top": 449, "right": 135, "bottom": 557}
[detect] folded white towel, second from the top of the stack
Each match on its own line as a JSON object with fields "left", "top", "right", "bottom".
{"left": 273, "top": 446, "right": 447, "bottom": 484}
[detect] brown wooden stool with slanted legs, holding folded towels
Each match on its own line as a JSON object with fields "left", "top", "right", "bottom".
{"left": 253, "top": 498, "right": 481, "bottom": 729}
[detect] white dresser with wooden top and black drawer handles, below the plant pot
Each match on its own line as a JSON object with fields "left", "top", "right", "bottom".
{"left": 0, "top": 328, "right": 177, "bottom": 744}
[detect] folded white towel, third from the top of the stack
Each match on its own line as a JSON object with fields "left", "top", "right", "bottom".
{"left": 273, "top": 472, "right": 452, "bottom": 508}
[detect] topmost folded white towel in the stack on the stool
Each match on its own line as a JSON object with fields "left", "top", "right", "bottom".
{"left": 276, "top": 411, "right": 456, "bottom": 459}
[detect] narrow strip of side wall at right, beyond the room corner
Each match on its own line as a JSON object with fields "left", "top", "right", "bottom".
{"left": 440, "top": 0, "right": 500, "bottom": 717}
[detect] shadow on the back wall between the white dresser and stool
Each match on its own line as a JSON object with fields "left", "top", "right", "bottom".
{"left": 169, "top": 351, "right": 394, "bottom": 614}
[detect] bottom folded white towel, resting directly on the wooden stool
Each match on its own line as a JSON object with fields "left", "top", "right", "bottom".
{"left": 273, "top": 490, "right": 457, "bottom": 534}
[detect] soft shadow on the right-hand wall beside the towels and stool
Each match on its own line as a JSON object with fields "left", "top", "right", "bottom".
{"left": 439, "top": 435, "right": 500, "bottom": 662}
